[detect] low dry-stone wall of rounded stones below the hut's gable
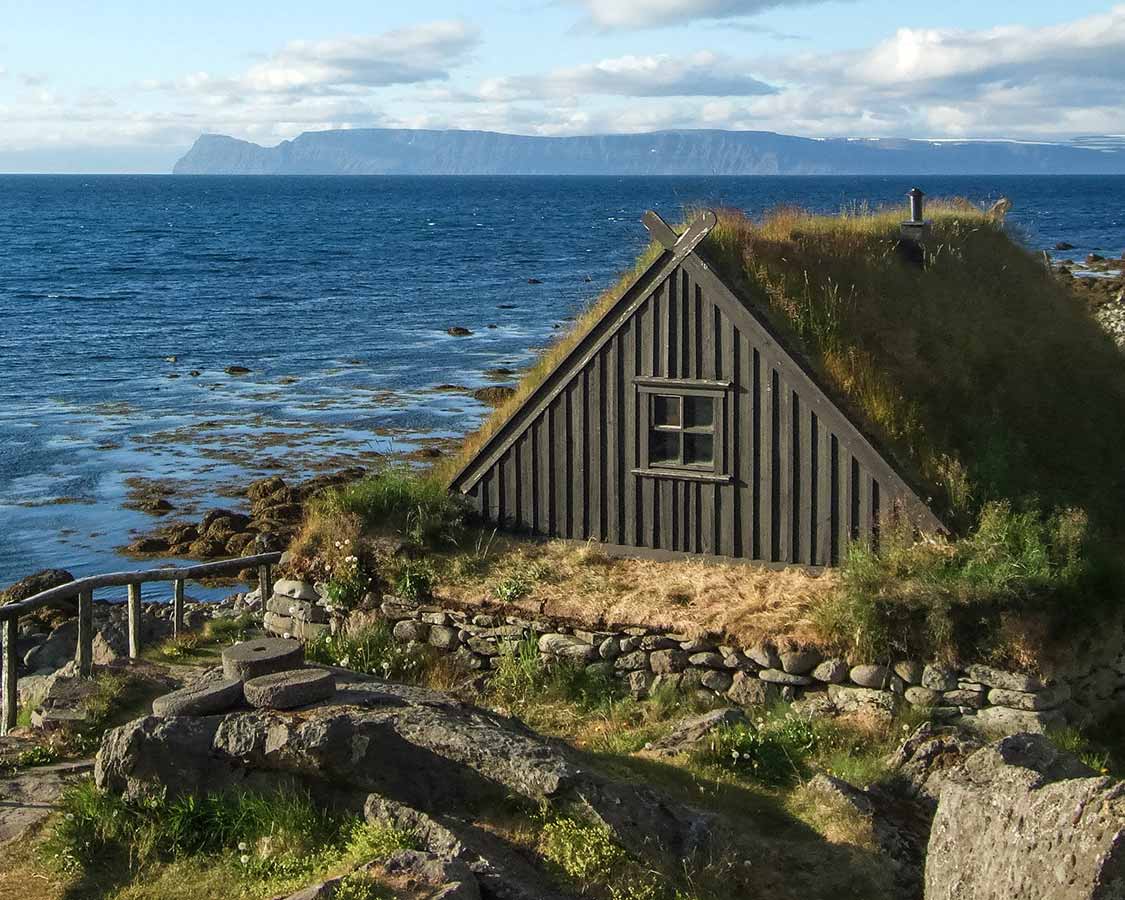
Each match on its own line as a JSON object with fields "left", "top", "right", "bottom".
{"left": 258, "top": 581, "right": 1125, "bottom": 734}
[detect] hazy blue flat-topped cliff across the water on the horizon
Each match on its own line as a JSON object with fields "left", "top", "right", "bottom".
{"left": 173, "top": 128, "right": 1125, "bottom": 176}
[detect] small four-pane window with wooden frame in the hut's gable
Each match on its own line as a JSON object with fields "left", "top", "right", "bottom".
{"left": 637, "top": 378, "right": 727, "bottom": 478}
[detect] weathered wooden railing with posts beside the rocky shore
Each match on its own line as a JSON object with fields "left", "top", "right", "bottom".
{"left": 0, "top": 552, "right": 281, "bottom": 735}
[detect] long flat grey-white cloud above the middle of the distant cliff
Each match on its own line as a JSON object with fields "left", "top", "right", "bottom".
{"left": 479, "top": 51, "right": 774, "bottom": 100}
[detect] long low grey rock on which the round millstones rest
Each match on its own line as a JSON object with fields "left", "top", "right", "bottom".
{"left": 96, "top": 669, "right": 714, "bottom": 858}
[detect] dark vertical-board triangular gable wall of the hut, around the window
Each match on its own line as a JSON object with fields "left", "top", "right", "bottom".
{"left": 452, "top": 211, "right": 941, "bottom": 566}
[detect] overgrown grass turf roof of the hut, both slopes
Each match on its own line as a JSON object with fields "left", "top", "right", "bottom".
{"left": 441, "top": 200, "right": 1125, "bottom": 530}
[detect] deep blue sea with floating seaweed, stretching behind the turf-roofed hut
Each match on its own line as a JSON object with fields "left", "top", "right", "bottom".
{"left": 0, "top": 176, "right": 1125, "bottom": 593}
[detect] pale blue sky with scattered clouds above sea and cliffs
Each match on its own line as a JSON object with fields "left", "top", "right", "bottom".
{"left": 0, "top": 0, "right": 1125, "bottom": 173}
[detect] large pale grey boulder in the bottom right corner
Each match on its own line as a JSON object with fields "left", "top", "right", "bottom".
{"left": 926, "top": 735, "right": 1125, "bottom": 900}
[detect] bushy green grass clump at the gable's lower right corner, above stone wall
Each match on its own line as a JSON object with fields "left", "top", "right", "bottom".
{"left": 815, "top": 502, "right": 1125, "bottom": 666}
